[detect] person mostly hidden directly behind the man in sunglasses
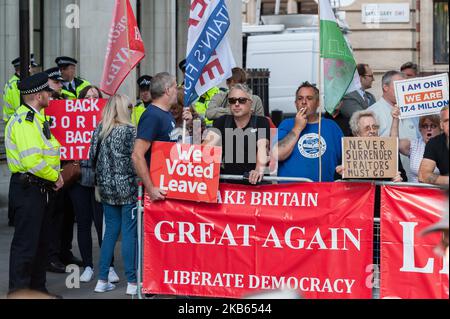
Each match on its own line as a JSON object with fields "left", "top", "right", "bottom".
{"left": 206, "top": 68, "right": 264, "bottom": 121}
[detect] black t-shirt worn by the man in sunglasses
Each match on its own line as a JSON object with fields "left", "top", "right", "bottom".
{"left": 214, "top": 115, "right": 270, "bottom": 175}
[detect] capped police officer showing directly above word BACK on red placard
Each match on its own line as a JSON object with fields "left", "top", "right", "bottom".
{"left": 55, "top": 56, "right": 91, "bottom": 100}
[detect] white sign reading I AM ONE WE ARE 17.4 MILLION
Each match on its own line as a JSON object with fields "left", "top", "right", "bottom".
{"left": 394, "top": 73, "right": 448, "bottom": 119}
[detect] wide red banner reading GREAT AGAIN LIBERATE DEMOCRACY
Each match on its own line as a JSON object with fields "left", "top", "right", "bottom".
{"left": 143, "top": 183, "right": 374, "bottom": 298}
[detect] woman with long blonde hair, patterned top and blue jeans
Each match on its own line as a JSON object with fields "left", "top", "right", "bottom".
{"left": 89, "top": 94, "right": 138, "bottom": 295}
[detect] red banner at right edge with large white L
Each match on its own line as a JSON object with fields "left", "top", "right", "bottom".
{"left": 380, "top": 186, "right": 449, "bottom": 299}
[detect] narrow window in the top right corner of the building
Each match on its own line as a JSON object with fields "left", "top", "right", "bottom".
{"left": 433, "top": 0, "right": 449, "bottom": 64}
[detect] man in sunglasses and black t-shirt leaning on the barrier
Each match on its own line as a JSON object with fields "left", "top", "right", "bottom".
{"left": 204, "top": 84, "right": 270, "bottom": 185}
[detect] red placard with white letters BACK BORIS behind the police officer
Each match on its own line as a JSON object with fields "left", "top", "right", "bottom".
{"left": 45, "top": 99, "right": 108, "bottom": 160}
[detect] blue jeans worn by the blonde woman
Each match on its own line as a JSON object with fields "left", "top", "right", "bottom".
{"left": 99, "top": 203, "right": 137, "bottom": 283}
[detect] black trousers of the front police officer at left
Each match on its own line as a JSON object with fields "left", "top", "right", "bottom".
{"left": 9, "top": 174, "right": 54, "bottom": 292}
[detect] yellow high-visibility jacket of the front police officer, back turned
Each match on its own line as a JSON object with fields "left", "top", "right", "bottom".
{"left": 5, "top": 105, "right": 61, "bottom": 182}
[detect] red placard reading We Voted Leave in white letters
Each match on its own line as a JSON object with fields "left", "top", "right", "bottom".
{"left": 150, "top": 142, "right": 222, "bottom": 203}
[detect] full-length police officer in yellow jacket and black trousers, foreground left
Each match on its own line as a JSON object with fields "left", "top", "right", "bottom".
{"left": 5, "top": 72, "right": 64, "bottom": 293}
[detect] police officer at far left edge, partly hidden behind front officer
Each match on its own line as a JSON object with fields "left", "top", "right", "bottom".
{"left": 3, "top": 54, "right": 38, "bottom": 123}
